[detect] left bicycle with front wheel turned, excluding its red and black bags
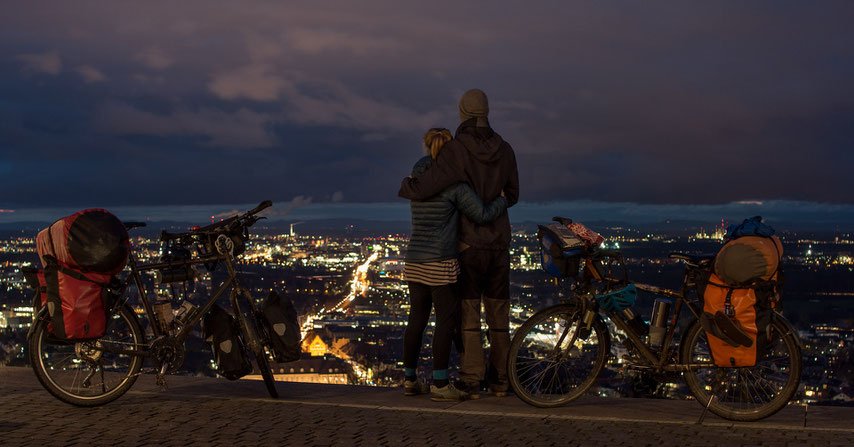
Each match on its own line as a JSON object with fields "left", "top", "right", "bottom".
{"left": 27, "top": 200, "right": 278, "bottom": 407}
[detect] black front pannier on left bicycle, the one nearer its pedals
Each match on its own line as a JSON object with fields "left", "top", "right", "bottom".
{"left": 202, "top": 304, "right": 252, "bottom": 380}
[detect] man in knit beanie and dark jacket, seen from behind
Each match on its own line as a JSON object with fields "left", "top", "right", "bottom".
{"left": 398, "top": 89, "right": 519, "bottom": 398}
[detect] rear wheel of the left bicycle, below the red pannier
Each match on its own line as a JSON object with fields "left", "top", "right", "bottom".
{"left": 29, "top": 304, "right": 145, "bottom": 407}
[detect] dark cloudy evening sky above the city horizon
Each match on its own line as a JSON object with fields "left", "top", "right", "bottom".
{"left": 0, "top": 0, "right": 854, "bottom": 217}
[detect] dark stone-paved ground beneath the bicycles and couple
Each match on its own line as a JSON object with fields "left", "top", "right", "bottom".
{"left": 0, "top": 368, "right": 854, "bottom": 447}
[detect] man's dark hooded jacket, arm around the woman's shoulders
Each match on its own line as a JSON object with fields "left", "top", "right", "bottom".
{"left": 398, "top": 119, "right": 519, "bottom": 249}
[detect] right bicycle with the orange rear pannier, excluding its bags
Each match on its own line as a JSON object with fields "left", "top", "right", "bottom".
{"left": 508, "top": 217, "right": 802, "bottom": 421}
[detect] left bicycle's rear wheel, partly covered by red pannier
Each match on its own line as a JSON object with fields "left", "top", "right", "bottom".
{"left": 29, "top": 305, "right": 144, "bottom": 407}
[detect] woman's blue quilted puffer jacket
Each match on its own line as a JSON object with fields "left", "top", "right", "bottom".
{"left": 406, "top": 156, "right": 507, "bottom": 262}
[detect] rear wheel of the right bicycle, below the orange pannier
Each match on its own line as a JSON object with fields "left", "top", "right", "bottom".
{"left": 680, "top": 315, "right": 803, "bottom": 421}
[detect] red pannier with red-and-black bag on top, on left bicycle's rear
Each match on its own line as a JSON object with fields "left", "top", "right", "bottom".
{"left": 29, "top": 209, "right": 130, "bottom": 339}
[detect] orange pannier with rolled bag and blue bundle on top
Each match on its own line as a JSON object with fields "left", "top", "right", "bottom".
{"left": 700, "top": 216, "right": 783, "bottom": 367}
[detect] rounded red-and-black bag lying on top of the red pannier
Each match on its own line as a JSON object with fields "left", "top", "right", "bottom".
{"left": 36, "top": 209, "right": 130, "bottom": 275}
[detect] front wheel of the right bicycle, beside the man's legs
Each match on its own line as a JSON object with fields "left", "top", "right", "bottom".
{"left": 507, "top": 304, "right": 611, "bottom": 408}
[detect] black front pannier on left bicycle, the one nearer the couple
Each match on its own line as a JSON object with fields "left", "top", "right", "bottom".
{"left": 261, "top": 292, "right": 302, "bottom": 363}
